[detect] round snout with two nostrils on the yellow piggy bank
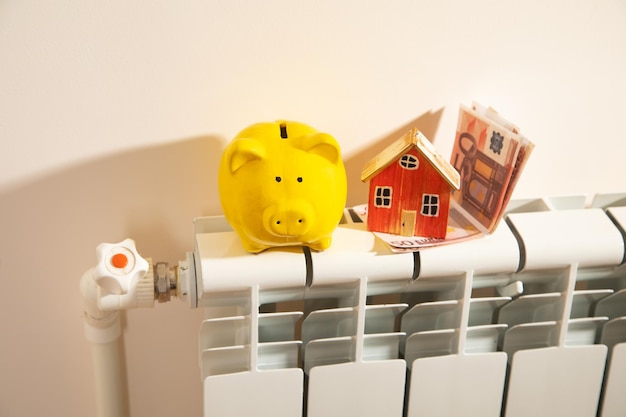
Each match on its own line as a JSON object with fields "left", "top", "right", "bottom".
{"left": 263, "top": 206, "right": 314, "bottom": 237}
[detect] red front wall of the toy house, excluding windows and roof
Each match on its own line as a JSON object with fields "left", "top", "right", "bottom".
{"left": 367, "top": 149, "right": 450, "bottom": 238}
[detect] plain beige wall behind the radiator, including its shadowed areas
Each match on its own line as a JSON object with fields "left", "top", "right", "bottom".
{"left": 0, "top": 0, "right": 626, "bottom": 417}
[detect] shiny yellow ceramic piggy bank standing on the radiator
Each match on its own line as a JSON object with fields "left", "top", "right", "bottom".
{"left": 218, "top": 121, "right": 347, "bottom": 253}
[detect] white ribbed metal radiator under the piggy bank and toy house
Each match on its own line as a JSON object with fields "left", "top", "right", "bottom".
{"left": 83, "top": 195, "right": 626, "bottom": 417}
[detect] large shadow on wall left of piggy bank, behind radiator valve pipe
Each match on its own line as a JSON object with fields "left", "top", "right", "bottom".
{"left": 0, "top": 136, "right": 224, "bottom": 416}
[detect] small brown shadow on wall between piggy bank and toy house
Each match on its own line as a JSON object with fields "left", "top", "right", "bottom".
{"left": 344, "top": 108, "right": 443, "bottom": 207}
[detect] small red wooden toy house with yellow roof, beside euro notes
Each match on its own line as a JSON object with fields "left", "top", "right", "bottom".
{"left": 361, "top": 129, "right": 460, "bottom": 239}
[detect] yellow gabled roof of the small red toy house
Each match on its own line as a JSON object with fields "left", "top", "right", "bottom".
{"left": 361, "top": 129, "right": 461, "bottom": 190}
